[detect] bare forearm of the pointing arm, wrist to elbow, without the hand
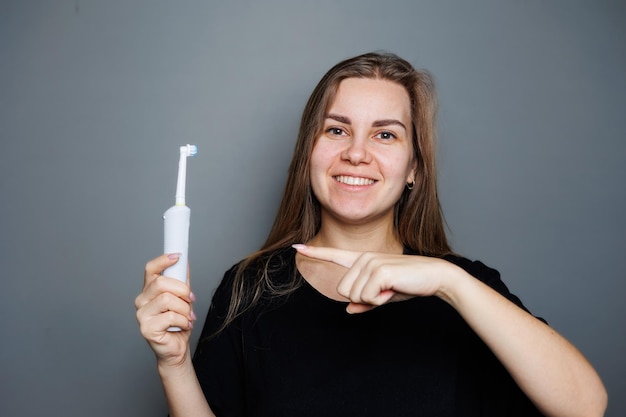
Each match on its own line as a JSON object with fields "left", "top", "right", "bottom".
{"left": 435, "top": 261, "right": 607, "bottom": 417}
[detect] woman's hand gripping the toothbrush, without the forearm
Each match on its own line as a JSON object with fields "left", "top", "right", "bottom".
{"left": 135, "top": 254, "right": 196, "bottom": 367}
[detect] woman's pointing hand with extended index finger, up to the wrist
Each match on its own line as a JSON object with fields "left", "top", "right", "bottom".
{"left": 294, "top": 245, "right": 456, "bottom": 313}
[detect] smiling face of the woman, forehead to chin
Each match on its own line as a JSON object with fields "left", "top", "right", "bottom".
{"left": 311, "top": 78, "right": 416, "bottom": 228}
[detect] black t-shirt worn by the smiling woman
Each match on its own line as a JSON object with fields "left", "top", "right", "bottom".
{"left": 194, "top": 248, "right": 541, "bottom": 417}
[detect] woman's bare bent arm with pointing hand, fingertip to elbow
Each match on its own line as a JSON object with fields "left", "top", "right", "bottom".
{"left": 295, "top": 245, "right": 607, "bottom": 417}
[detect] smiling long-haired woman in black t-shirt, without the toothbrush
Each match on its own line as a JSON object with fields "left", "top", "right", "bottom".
{"left": 136, "top": 53, "right": 606, "bottom": 417}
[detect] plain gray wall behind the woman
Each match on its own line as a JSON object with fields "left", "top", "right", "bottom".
{"left": 0, "top": 0, "right": 626, "bottom": 417}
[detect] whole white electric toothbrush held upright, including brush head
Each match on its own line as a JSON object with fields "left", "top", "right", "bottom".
{"left": 163, "top": 145, "right": 198, "bottom": 332}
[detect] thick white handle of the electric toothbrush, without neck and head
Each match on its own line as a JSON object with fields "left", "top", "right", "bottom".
{"left": 163, "top": 206, "right": 191, "bottom": 332}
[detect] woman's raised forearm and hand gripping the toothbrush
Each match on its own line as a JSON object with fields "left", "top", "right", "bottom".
{"left": 135, "top": 255, "right": 214, "bottom": 417}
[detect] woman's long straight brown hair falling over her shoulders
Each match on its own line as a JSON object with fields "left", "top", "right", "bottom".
{"left": 214, "top": 53, "right": 451, "bottom": 330}
